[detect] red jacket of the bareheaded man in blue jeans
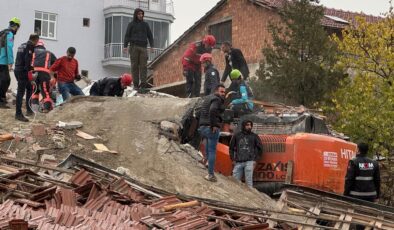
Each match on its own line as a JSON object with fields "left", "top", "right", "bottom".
{"left": 50, "top": 56, "right": 79, "bottom": 83}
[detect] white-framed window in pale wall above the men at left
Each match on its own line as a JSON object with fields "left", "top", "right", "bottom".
{"left": 34, "top": 11, "right": 57, "bottom": 39}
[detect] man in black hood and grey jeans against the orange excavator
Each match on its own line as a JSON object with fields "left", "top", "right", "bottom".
{"left": 229, "top": 120, "right": 263, "bottom": 187}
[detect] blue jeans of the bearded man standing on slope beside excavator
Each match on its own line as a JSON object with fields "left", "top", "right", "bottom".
{"left": 198, "top": 126, "right": 220, "bottom": 175}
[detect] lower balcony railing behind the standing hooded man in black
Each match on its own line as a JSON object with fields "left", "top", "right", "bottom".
{"left": 104, "top": 43, "right": 164, "bottom": 62}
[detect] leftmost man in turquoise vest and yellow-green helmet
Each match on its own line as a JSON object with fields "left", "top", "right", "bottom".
{"left": 0, "top": 17, "right": 21, "bottom": 108}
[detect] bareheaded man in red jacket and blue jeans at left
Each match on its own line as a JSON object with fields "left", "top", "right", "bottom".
{"left": 50, "top": 47, "right": 84, "bottom": 101}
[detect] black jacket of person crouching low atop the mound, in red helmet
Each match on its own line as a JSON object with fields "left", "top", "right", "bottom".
{"left": 90, "top": 77, "right": 124, "bottom": 97}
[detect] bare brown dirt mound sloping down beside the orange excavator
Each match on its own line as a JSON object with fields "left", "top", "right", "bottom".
{"left": 43, "top": 97, "right": 275, "bottom": 208}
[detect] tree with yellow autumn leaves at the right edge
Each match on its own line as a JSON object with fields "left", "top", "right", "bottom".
{"left": 331, "top": 10, "right": 394, "bottom": 155}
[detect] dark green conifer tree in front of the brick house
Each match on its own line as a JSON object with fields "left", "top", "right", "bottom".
{"left": 252, "top": 0, "right": 344, "bottom": 106}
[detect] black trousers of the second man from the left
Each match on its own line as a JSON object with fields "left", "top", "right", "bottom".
{"left": 14, "top": 70, "right": 32, "bottom": 115}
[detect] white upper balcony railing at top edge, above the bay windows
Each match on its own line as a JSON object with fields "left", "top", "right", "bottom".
{"left": 104, "top": 0, "right": 174, "bottom": 15}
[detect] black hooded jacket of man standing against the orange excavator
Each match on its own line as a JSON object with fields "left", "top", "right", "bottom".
{"left": 229, "top": 120, "right": 263, "bottom": 162}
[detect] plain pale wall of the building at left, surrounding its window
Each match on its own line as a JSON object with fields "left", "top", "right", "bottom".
{"left": 0, "top": 0, "right": 130, "bottom": 81}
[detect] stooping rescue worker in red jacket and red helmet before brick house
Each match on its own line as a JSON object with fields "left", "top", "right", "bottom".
{"left": 182, "top": 35, "right": 216, "bottom": 97}
